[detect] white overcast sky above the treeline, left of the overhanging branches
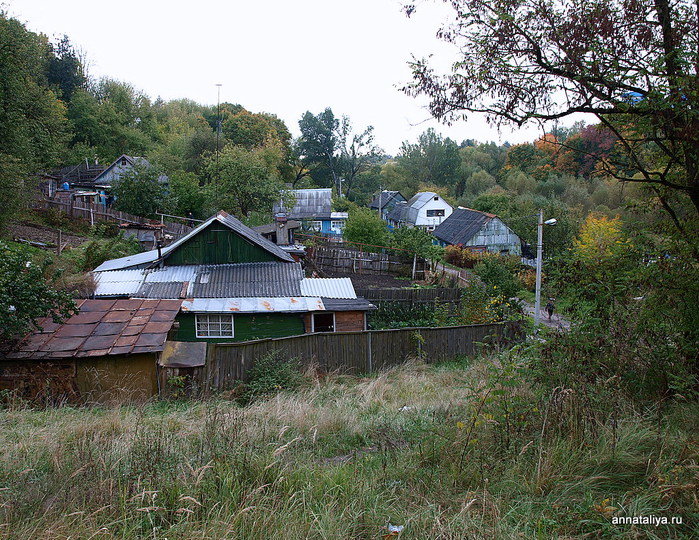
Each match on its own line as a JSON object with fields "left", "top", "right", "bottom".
{"left": 8, "top": 0, "right": 540, "bottom": 154}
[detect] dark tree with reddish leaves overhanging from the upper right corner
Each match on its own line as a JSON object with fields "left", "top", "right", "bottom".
{"left": 404, "top": 0, "right": 699, "bottom": 232}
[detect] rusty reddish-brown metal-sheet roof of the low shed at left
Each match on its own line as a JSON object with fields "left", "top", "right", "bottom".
{"left": 7, "top": 299, "right": 181, "bottom": 360}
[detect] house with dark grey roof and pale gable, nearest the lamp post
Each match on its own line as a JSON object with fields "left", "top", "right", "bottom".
{"left": 432, "top": 207, "right": 522, "bottom": 255}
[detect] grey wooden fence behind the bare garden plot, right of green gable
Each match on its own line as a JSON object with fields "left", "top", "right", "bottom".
{"left": 306, "top": 245, "right": 427, "bottom": 279}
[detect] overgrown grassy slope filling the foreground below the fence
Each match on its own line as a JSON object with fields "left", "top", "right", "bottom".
{"left": 0, "top": 355, "right": 699, "bottom": 539}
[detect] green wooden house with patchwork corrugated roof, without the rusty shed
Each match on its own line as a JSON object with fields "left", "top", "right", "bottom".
{"left": 93, "top": 212, "right": 374, "bottom": 342}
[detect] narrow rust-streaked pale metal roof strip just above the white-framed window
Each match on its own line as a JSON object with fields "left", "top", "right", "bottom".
{"left": 182, "top": 296, "right": 325, "bottom": 313}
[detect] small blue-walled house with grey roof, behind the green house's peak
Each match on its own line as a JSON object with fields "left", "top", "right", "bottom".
{"left": 273, "top": 188, "right": 348, "bottom": 236}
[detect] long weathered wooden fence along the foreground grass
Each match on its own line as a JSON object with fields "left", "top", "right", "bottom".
{"left": 159, "top": 322, "right": 522, "bottom": 397}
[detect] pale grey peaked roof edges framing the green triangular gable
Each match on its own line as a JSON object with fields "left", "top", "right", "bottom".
{"left": 94, "top": 210, "right": 294, "bottom": 272}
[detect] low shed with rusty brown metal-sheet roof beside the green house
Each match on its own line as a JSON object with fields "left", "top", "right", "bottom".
{"left": 0, "top": 299, "right": 182, "bottom": 403}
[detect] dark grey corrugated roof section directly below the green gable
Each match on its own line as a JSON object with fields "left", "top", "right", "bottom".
{"left": 133, "top": 262, "right": 304, "bottom": 298}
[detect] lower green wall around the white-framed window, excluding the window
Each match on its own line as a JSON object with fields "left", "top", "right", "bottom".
{"left": 174, "top": 313, "right": 305, "bottom": 343}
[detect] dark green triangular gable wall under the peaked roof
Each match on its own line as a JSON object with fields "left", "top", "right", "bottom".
{"left": 166, "top": 222, "right": 279, "bottom": 265}
